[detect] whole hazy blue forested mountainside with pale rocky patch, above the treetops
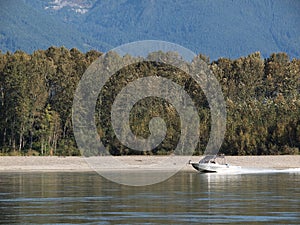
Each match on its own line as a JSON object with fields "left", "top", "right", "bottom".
{"left": 0, "top": 0, "right": 300, "bottom": 59}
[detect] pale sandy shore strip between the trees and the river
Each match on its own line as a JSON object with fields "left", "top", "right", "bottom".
{"left": 0, "top": 155, "right": 300, "bottom": 172}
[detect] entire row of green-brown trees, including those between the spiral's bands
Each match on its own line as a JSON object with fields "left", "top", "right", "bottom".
{"left": 0, "top": 47, "right": 300, "bottom": 155}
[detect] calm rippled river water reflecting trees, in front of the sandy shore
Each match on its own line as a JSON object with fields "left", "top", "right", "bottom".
{"left": 0, "top": 172, "right": 300, "bottom": 224}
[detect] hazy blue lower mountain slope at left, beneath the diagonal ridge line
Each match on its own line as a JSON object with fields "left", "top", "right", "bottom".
{"left": 0, "top": 0, "right": 107, "bottom": 52}
